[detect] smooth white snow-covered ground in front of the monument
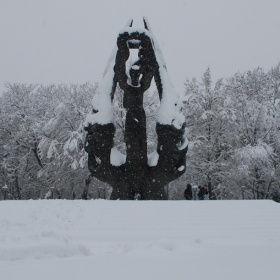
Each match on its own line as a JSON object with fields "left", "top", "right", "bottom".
{"left": 0, "top": 200, "right": 280, "bottom": 280}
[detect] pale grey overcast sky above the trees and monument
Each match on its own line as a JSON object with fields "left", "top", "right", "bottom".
{"left": 0, "top": 0, "right": 280, "bottom": 93}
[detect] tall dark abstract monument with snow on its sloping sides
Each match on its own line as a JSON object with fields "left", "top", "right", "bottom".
{"left": 84, "top": 18, "right": 188, "bottom": 200}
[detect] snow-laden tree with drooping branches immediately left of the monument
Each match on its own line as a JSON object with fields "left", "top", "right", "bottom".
{"left": 38, "top": 84, "right": 96, "bottom": 199}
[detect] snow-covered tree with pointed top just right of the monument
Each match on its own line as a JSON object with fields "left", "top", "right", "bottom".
{"left": 184, "top": 69, "right": 235, "bottom": 199}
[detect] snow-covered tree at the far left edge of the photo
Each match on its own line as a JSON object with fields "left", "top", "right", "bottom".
{"left": 0, "top": 84, "right": 47, "bottom": 199}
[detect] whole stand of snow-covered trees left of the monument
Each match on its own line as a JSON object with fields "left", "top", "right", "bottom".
{"left": 0, "top": 84, "right": 96, "bottom": 199}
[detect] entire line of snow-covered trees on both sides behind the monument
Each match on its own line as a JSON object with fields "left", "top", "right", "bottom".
{"left": 0, "top": 64, "right": 280, "bottom": 202}
